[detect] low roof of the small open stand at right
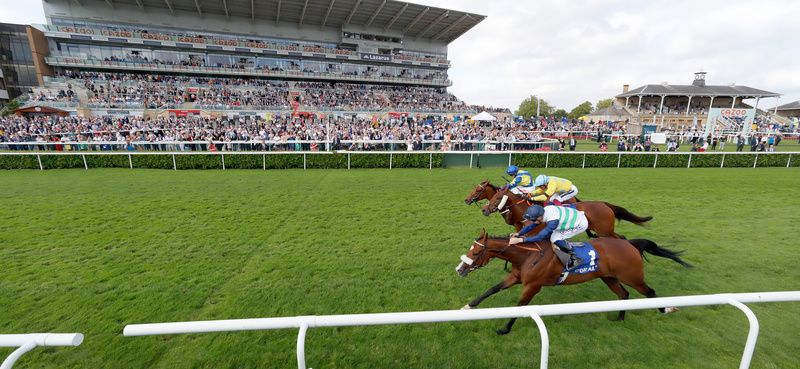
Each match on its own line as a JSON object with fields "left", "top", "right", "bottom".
{"left": 616, "top": 84, "right": 780, "bottom": 98}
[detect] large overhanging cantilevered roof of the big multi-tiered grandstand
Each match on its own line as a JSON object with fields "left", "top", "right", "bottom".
{"left": 44, "top": 0, "right": 486, "bottom": 42}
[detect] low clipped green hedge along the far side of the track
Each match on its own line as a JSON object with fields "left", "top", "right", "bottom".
{"left": 0, "top": 152, "right": 800, "bottom": 170}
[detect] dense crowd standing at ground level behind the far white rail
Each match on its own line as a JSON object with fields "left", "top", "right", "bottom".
{"left": 0, "top": 116, "right": 782, "bottom": 151}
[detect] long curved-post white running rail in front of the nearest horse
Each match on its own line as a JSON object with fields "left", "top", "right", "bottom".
{"left": 123, "top": 291, "right": 800, "bottom": 369}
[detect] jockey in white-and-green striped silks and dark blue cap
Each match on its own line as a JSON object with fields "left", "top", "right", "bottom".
{"left": 508, "top": 205, "right": 589, "bottom": 267}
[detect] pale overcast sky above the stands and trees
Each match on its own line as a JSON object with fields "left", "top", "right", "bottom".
{"left": 0, "top": 0, "right": 800, "bottom": 111}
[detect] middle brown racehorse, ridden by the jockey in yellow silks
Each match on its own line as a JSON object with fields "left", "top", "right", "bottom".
{"left": 481, "top": 185, "right": 653, "bottom": 238}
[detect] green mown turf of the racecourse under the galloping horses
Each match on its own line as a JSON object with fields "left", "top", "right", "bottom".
{"left": 0, "top": 168, "right": 800, "bottom": 369}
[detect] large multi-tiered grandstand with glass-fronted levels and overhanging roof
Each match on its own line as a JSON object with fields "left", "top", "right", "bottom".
{"left": 23, "top": 0, "right": 485, "bottom": 117}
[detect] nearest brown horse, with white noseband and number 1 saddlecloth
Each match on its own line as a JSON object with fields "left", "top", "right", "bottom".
{"left": 456, "top": 231, "right": 691, "bottom": 334}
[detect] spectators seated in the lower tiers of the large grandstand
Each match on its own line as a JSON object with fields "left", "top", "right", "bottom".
{"left": 45, "top": 71, "right": 476, "bottom": 112}
